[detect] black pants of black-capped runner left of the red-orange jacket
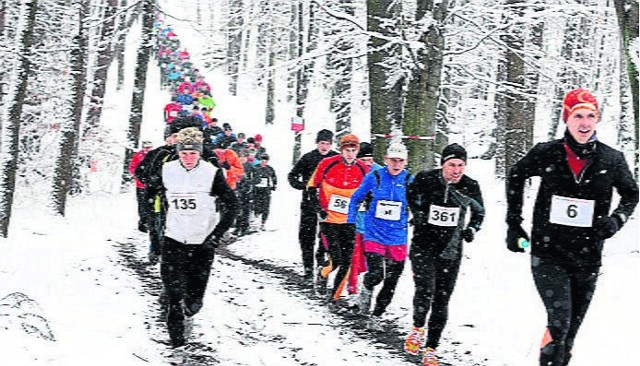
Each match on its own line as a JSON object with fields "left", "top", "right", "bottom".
{"left": 298, "top": 201, "right": 325, "bottom": 273}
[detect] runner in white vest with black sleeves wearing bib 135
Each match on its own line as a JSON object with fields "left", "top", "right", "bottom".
{"left": 160, "top": 127, "right": 238, "bottom": 347}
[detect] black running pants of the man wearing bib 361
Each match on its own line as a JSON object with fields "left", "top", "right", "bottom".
{"left": 410, "top": 246, "right": 461, "bottom": 348}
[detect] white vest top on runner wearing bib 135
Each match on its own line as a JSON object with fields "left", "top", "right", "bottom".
{"left": 162, "top": 160, "right": 218, "bottom": 244}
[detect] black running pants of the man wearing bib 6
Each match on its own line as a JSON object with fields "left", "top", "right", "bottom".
{"left": 531, "top": 256, "right": 599, "bottom": 366}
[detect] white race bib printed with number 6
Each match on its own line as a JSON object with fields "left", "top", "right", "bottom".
{"left": 549, "top": 195, "right": 595, "bottom": 227}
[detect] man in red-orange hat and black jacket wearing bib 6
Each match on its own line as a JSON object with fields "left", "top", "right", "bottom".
{"left": 506, "top": 88, "right": 638, "bottom": 366}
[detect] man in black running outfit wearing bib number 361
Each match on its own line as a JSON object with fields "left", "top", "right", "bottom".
{"left": 404, "top": 144, "right": 484, "bottom": 366}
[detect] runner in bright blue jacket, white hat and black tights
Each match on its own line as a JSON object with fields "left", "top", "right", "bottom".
{"left": 347, "top": 143, "right": 413, "bottom": 330}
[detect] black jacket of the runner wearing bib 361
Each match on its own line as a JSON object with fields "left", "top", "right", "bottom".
{"left": 407, "top": 169, "right": 485, "bottom": 259}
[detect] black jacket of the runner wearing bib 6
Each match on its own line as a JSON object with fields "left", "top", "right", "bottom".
{"left": 507, "top": 139, "right": 638, "bottom": 266}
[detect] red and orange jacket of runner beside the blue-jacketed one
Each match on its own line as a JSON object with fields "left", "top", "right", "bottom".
{"left": 309, "top": 155, "right": 369, "bottom": 224}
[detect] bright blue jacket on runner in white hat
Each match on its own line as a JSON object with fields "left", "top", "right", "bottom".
{"left": 347, "top": 168, "right": 413, "bottom": 245}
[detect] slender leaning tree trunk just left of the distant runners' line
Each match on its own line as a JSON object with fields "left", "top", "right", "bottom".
{"left": 122, "top": 0, "right": 156, "bottom": 185}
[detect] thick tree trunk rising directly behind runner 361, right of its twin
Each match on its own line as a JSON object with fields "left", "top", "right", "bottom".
{"left": 404, "top": 0, "right": 449, "bottom": 171}
